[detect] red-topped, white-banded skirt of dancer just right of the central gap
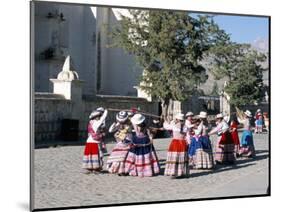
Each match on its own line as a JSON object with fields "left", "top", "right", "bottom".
{"left": 164, "top": 139, "right": 189, "bottom": 177}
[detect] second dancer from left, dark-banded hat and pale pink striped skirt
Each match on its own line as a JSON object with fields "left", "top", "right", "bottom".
{"left": 107, "top": 111, "right": 132, "bottom": 175}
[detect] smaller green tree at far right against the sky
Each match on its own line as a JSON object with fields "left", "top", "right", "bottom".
{"left": 210, "top": 43, "right": 266, "bottom": 106}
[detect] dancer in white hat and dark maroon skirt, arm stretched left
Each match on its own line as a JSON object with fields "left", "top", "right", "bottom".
{"left": 208, "top": 113, "right": 236, "bottom": 164}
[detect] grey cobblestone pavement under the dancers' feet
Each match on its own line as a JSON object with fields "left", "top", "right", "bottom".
{"left": 34, "top": 134, "right": 269, "bottom": 208}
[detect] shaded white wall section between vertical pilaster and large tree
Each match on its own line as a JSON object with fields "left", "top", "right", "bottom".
{"left": 97, "top": 8, "right": 142, "bottom": 96}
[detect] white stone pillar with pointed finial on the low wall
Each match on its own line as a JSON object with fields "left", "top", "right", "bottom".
{"left": 50, "top": 56, "right": 84, "bottom": 119}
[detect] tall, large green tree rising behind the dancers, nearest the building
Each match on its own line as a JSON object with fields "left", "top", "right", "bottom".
{"left": 110, "top": 10, "right": 229, "bottom": 116}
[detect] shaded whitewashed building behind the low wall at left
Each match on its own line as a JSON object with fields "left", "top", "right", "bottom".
{"left": 34, "top": 2, "right": 142, "bottom": 96}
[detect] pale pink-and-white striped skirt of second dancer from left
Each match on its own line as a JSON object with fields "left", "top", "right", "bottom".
{"left": 106, "top": 142, "right": 130, "bottom": 174}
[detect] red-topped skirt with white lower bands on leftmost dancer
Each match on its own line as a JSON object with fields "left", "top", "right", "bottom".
{"left": 82, "top": 143, "right": 103, "bottom": 170}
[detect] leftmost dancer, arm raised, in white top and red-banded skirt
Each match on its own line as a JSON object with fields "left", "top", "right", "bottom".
{"left": 83, "top": 110, "right": 107, "bottom": 173}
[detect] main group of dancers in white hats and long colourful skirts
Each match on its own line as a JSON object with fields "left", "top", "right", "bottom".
{"left": 83, "top": 108, "right": 255, "bottom": 178}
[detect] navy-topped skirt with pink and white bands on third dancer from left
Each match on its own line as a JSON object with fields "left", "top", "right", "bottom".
{"left": 125, "top": 144, "right": 160, "bottom": 177}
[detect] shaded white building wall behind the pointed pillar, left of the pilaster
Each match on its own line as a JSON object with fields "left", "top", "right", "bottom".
{"left": 35, "top": 2, "right": 96, "bottom": 94}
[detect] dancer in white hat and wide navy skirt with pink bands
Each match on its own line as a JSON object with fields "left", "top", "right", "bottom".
{"left": 125, "top": 113, "right": 160, "bottom": 177}
